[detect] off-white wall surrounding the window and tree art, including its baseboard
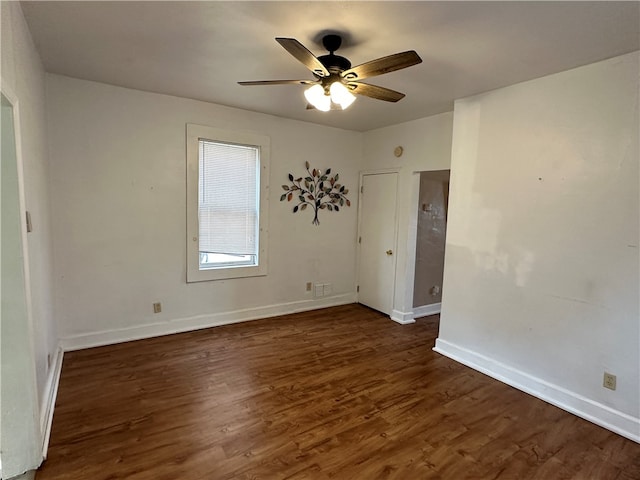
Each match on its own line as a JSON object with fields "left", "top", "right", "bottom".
{"left": 47, "top": 75, "right": 362, "bottom": 348}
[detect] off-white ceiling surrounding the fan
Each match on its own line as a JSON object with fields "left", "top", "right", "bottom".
{"left": 22, "top": 1, "right": 640, "bottom": 131}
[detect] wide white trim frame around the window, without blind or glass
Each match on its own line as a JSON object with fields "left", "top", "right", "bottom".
{"left": 187, "top": 123, "right": 271, "bottom": 283}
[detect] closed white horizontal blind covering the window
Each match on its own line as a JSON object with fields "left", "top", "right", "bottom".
{"left": 198, "top": 139, "right": 260, "bottom": 255}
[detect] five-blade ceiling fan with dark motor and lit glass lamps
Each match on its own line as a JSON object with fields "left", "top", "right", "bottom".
{"left": 238, "top": 34, "right": 422, "bottom": 112}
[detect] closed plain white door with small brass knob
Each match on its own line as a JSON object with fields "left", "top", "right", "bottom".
{"left": 358, "top": 172, "right": 398, "bottom": 315}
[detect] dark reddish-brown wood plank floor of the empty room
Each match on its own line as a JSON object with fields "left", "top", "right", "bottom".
{"left": 36, "top": 305, "right": 640, "bottom": 480}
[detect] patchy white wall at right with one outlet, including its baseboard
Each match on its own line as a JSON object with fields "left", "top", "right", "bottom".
{"left": 436, "top": 52, "right": 640, "bottom": 441}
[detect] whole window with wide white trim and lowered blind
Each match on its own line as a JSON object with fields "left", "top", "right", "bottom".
{"left": 187, "top": 124, "right": 269, "bottom": 282}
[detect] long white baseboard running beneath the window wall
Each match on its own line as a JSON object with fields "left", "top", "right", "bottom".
{"left": 61, "top": 293, "right": 356, "bottom": 352}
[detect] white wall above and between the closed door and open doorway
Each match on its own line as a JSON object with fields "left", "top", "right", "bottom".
{"left": 363, "top": 112, "right": 453, "bottom": 323}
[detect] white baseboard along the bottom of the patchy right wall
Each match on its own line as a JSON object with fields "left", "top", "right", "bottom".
{"left": 433, "top": 339, "right": 640, "bottom": 443}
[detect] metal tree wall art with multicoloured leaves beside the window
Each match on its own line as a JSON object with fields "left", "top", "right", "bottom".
{"left": 280, "top": 162, "right": 351, "bottom": 225}
